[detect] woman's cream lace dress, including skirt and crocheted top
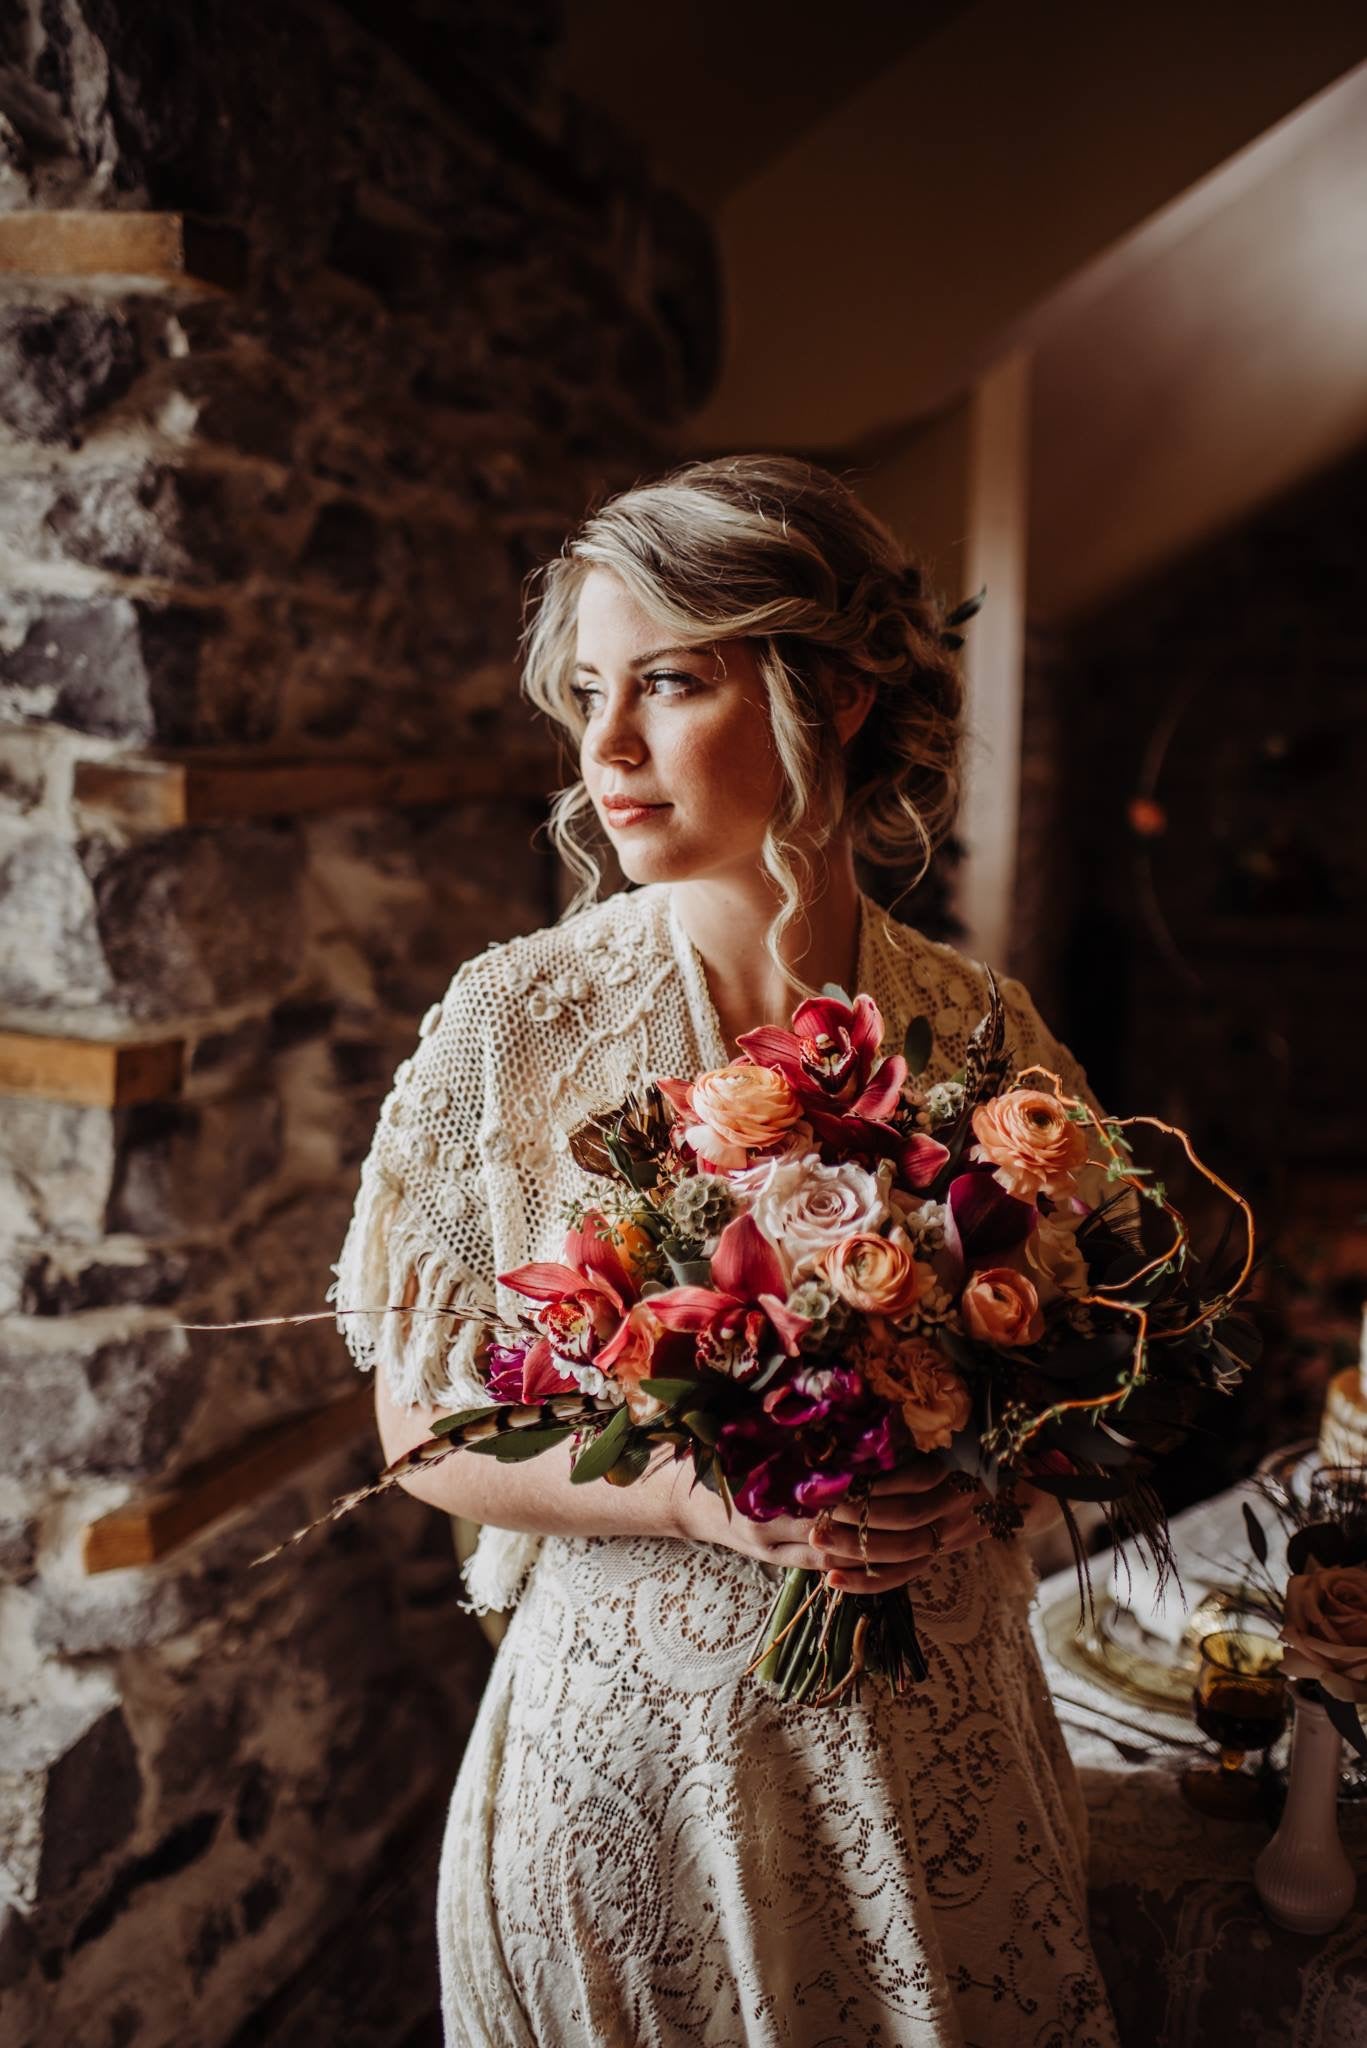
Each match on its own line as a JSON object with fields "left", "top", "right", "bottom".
{"left": 334, "top": 887, "right": 1117, "bottom": 2048}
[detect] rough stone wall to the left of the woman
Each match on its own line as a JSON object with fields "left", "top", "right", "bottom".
{"left": 0, "top": 0, "right": 715, "bottom": 2048}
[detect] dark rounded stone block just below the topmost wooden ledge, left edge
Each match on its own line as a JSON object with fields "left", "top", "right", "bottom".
{"left": 0, "top": 299, "right": 141, "bottom": 446}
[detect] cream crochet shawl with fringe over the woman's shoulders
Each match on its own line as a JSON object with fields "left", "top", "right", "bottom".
{"left": 328, "top": 883, "right": 1094, "bottom": 1614}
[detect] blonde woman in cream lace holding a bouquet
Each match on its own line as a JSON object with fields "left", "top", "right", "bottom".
{"left": 334, "top": 457, "right": 1115, "bottom": 2048}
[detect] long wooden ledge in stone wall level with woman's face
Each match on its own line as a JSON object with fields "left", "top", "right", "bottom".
{"left": 74, "top": 750, "right": 553, "bottom": 831}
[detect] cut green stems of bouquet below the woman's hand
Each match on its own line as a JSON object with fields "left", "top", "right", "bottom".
{"left": 746, "top": 1571, "right": 926, "bottom": 1706}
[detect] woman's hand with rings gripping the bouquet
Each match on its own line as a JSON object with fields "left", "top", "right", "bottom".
{"left": 812, "top": 1458, "right": 988, "bottom": 1593}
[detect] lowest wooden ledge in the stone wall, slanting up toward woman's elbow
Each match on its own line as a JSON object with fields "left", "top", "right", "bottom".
{"left": 82, "top": 1380, "right": 381, "bottom": 1573}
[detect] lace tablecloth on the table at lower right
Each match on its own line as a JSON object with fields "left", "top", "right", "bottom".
{"left": 1035, "top": 1487, "right": 1367, "bottom": 2048}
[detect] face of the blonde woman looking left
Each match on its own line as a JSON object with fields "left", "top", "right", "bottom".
{"left": 574, "top": 569, "right": 783, "bottom": 883}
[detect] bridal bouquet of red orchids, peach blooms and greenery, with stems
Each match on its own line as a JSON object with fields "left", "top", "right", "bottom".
{"left": 383, "top": 983, "right": 1256, "bottom": 1704}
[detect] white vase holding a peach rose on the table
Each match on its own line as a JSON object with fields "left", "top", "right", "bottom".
{"left": 1252, "top": 1692, "right": 1357, "bottom": 1933}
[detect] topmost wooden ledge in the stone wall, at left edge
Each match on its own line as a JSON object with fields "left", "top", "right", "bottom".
{"left": 0, "top": 209, "right": 246, "bottom": 291}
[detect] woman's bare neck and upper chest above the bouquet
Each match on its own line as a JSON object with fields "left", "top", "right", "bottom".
{"left": 670, "top": 848, "right": 859, "bottom": 1057}
